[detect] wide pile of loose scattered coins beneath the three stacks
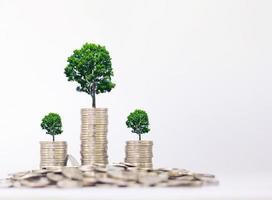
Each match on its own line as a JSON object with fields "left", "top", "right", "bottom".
{"left": 0, "top": 163, "right": 218, "bottom": 188}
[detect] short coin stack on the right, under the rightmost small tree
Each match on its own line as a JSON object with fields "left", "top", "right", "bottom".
{"left": 125, "top": 140, "right": 153, "bottom": 169}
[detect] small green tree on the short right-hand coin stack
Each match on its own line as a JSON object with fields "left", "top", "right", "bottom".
{"left": 126, "top": 109, "right": 150, "bottom": 140}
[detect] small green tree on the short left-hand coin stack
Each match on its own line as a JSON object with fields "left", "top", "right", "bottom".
{"left": 41, "top": 113, "right": 62, "bottom": 142}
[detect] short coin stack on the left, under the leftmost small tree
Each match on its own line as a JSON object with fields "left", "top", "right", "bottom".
{"left": 40, "top": 141, "right": 67, "bottom": 168}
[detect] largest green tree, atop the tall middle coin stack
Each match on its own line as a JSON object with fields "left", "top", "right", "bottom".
{"left": 64, "top": 43, "right": 115, "bottom": 108}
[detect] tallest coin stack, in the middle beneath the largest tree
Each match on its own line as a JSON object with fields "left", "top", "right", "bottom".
{"left": 80, "top": 108, "right": 108, "bottom": 165}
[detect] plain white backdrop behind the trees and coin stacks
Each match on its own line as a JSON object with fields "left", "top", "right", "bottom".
{"left": 0, "top": 0, "right": 272, "bottom": 176}
